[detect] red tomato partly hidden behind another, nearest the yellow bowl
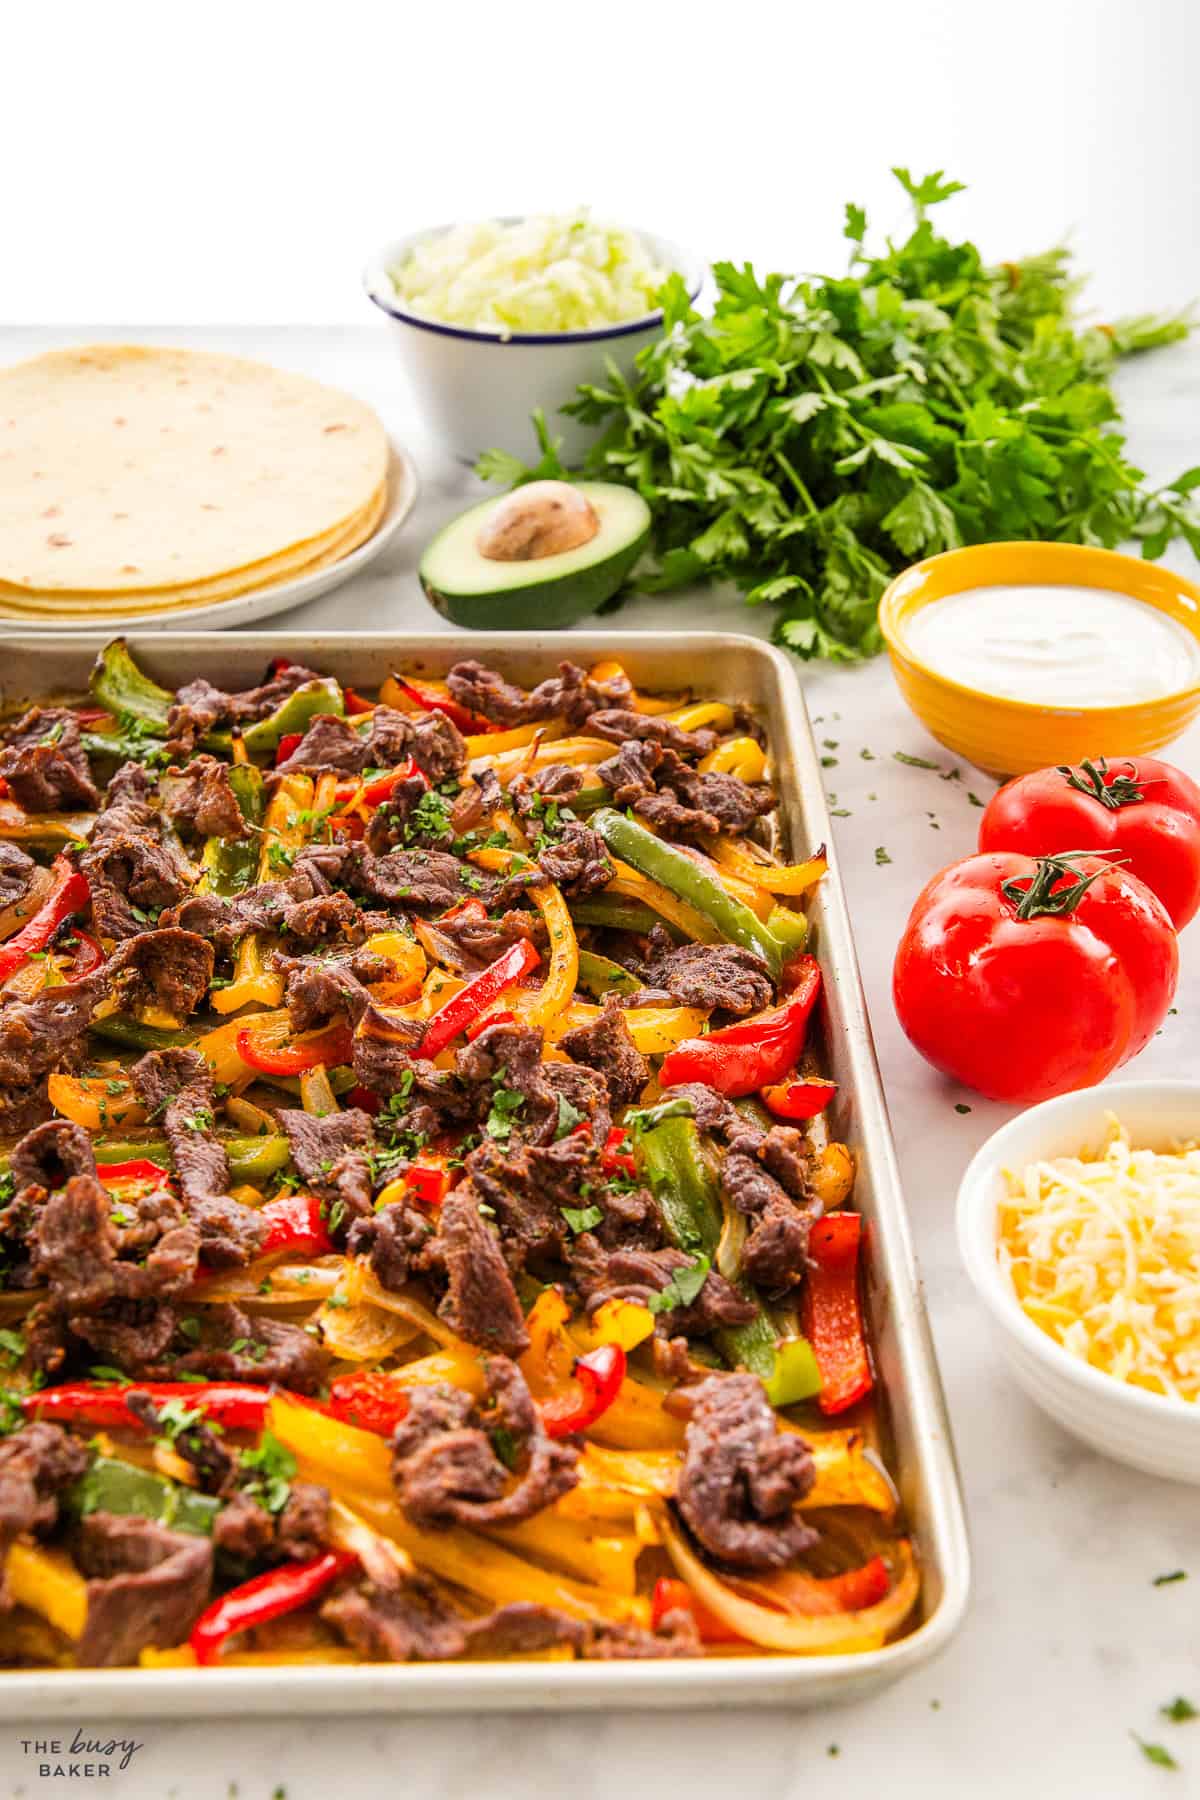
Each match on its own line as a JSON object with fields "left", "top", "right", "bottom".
{"left": 979, "top": 756, "right": 1200, "bottom": 931}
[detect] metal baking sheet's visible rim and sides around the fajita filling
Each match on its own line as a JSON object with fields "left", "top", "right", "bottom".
{"left": 0, "top": 632, "right": 970, "bottom": 1719}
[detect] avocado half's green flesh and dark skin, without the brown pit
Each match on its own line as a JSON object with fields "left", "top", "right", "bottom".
{"left": 419, "top": 481, "right": 649, "bottom": 632}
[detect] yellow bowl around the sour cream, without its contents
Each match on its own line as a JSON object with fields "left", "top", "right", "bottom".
{"left": 880, "top": 544, "right": 1200, "bottom": 776}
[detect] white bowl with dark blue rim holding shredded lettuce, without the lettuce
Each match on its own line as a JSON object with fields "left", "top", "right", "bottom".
{"left": 363, "top": 220, "right": 703, "bottom": 466}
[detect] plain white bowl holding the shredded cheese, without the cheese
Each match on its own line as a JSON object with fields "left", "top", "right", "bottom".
{"left": 957, "top": 1082, "right": 1200, "bottom": 1483}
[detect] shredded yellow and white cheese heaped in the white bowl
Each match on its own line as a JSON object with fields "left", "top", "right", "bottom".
{"left": 997, "top": 1116, "right": 1200, "bottom": 1400}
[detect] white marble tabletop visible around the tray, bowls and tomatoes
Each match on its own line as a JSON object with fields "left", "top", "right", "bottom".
{"left": 0, "top": 328, "right": 1200, "bottom": 1800}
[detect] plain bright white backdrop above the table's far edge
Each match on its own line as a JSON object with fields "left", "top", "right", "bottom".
{"left": 0, "top": 0, "right": 1200, "bottom": 324}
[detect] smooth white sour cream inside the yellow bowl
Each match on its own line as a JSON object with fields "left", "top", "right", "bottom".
{"left": 905, "top": 583, "right": 1200, "bottom": 707}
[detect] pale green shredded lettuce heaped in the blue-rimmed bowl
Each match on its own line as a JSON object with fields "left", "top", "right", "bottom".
{"left": 389, "top": 211, "right": 669, "bottom": 337}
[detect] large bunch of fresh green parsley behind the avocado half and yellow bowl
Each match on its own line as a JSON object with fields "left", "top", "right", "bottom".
{"left": 479, "top": 169, "right": 1200, "bottom": 661}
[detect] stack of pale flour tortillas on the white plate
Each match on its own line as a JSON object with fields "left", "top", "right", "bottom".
{"left": 0, "top": 344, "right": 389, "bottom": 625}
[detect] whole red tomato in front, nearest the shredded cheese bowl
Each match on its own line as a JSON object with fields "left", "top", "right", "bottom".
{"left": 892, "top": 851, "right": 1178, "bottom": 1103}
